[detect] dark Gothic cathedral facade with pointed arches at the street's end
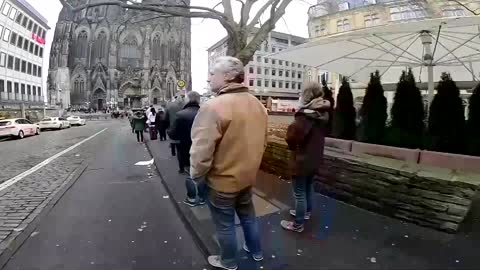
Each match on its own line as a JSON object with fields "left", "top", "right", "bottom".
{"left": 47, "top": 0, "right": 191, "bottom": 110}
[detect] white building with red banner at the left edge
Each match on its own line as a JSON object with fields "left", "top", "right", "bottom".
{"left": 0, "top": 0, "right": 50, "bottom": 118}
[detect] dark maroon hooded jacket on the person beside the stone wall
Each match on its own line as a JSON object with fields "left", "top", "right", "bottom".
{"left": 286, "top": 108, "right": 328, "bottom": 176}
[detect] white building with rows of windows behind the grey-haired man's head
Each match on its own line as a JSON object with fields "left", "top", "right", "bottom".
{"left": 208, "top": 32, "right": 307, "bottom": 110}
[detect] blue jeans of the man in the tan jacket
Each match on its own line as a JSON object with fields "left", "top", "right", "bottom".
{"left": 208, "top": 187, "right": 262, "bottom": 268}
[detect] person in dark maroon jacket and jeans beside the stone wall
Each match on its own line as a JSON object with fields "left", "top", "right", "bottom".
{"left": 280, "top": 83, "right": 330, "bottom": 232}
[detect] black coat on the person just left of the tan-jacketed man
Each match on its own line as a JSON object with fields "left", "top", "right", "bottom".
{"left": 168, "top": 102, "right": 200, "bottom": 146}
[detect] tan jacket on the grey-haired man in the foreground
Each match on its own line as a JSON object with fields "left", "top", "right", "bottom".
{"left": 190, "top": 83, "right": 268, "bottom": 193}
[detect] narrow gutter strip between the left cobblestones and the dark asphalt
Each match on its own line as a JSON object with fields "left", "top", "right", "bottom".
{"left": 0, "top": 161, "right": 87, "bottom": 269}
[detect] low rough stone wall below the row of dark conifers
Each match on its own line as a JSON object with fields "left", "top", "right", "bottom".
{"left": 261, "top": 138, "right": 480, "bottom": 232}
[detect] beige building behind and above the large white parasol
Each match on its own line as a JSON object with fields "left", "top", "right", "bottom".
{"left": 306, "top": 0, "right": 480, "bottom": 107}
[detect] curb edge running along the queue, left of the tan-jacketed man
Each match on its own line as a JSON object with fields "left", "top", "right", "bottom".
{"left": 145, "top": 143, "right": 218, "bottom": 257}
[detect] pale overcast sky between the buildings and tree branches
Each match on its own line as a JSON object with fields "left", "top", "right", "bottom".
{"left": 27, "top": 0, "right": 316, "bottom": 92}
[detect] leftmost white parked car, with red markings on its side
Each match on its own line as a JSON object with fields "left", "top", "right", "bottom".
{"left": 0, "top": 118, "right": 40, "bottom": 139}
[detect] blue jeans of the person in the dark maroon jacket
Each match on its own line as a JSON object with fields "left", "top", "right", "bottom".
{"left": 292, "top": 175, "right": 313, "bottom": 225}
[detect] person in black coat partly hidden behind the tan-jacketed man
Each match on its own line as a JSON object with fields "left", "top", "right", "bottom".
{"left": 168, "top": 91, "right": 205, "bottom": 207}
